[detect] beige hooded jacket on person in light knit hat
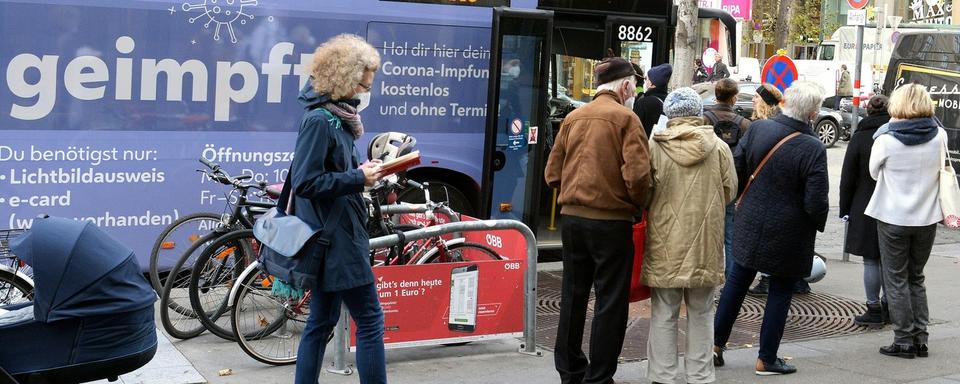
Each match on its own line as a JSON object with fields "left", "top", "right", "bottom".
{"left": 642, "top": 117, "right": 737, "bottom": 288}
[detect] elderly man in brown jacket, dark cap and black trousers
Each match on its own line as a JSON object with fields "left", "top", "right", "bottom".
{"left": 545, "top": 58, "right": 650, "bottom": 384}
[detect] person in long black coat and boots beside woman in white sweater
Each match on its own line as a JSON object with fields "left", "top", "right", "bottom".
{"left": 840, "top": 95, "right": 890, "bottom": 325}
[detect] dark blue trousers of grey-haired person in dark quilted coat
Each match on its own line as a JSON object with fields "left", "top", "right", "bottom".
{"left": 713, "top": 262, "right": 797, "bottom": 364}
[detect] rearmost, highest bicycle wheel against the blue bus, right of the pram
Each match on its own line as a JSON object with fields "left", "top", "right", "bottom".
{"left": 150, "top": 212, "right": 221, "bottom": 294}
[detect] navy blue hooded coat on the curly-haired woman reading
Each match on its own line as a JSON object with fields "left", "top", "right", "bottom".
{"left": 289, "top": 83, "right": 373, "bottom": 292}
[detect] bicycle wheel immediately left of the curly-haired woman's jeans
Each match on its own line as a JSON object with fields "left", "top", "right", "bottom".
{"left": 230, "top": 262, "right": 308, "bottom": 365}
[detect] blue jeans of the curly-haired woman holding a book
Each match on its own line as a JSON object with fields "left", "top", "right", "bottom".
{"left": 294, "top": 284, "right": 387, "bottom": 384}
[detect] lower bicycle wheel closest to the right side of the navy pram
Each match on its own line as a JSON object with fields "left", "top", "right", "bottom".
{"left": 160, "top": 232, "right": 223, "bottom": 340}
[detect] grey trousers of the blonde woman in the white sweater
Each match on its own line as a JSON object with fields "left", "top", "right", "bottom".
{"left": 877, "top": 220, "right": 937, "bottom": 346}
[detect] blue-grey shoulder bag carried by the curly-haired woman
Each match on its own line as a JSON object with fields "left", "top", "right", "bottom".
{"left": 253, "top": 176, "right": 343, "bottom": 289}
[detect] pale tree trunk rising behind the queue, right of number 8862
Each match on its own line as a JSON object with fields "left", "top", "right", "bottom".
{"left": 670, "top": 0, "right": 700, "bottom": 89}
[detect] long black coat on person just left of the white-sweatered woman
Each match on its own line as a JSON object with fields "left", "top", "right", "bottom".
{"left": 840, "top": 113, "right": 890, "bottom": 259}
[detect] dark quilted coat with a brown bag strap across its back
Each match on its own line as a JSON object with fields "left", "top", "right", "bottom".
{"left": 733, "top": 115, "right": 830, "bottom": 278}
